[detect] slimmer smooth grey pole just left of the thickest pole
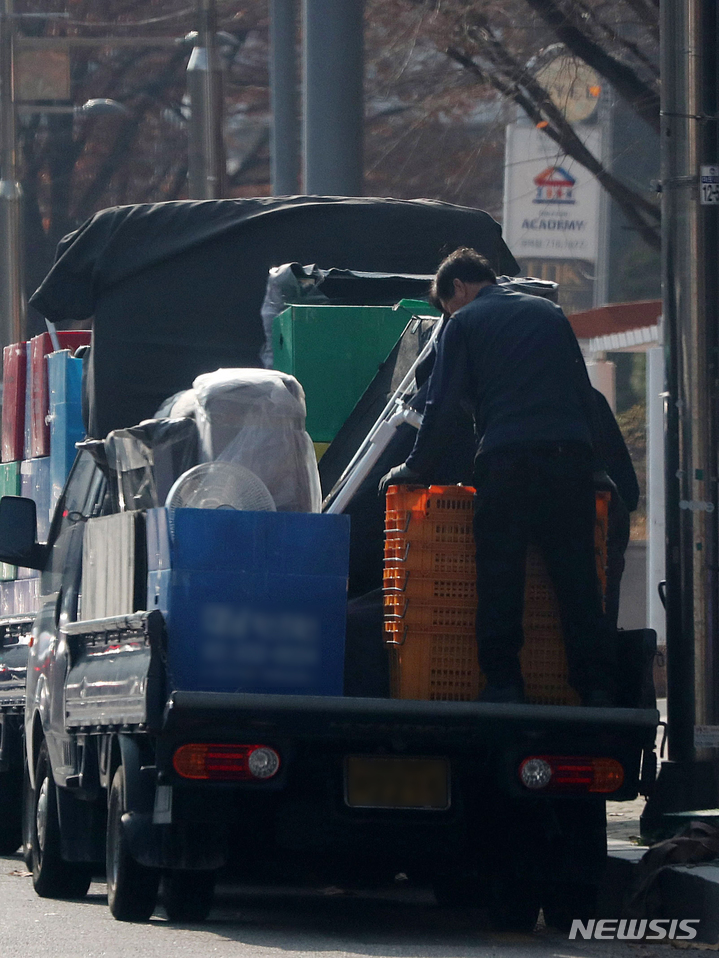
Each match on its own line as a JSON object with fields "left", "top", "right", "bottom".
{"left": 270, "top": 0, "right": 300, "bottom": 196}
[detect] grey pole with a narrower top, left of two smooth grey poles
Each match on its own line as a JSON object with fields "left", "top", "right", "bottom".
{"left": 187, "top": 0, "right": 225, "bottom": 200}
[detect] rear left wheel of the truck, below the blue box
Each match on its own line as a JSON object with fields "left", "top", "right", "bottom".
{"left": 106, "top": 765, "right": 160, "bottom": 921}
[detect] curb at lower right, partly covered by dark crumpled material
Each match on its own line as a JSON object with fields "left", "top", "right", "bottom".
{"left": 599, "top": 839, "right": 719, "bottom": 947}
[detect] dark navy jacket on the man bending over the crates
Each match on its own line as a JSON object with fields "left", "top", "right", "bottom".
{"left": 407, "top": 285, "right": 599, "bottom": 476}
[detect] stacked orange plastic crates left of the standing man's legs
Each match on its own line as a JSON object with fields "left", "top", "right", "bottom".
{"left": 384, "top": 486, "right": 484, "bottom": 702}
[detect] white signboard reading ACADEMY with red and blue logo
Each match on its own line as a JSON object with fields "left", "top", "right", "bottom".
{"left": 503, "top": 123, "right": 602, "bottom": 262}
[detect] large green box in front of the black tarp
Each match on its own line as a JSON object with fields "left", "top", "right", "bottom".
{"left": 272, "top": 301, "right": 436, "bottom": 443}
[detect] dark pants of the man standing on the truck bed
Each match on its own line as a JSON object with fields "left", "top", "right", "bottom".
{"left": 474, "top": 442, "right": 615, "bottom": 695}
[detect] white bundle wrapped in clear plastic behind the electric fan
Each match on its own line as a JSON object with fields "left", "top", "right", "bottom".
{"left": 166, "top": 369, "right": 322, "bottom": 512}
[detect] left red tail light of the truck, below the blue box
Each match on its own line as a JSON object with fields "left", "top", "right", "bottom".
{"left": 172, "top": 742, "right": 280, "bottom": 782}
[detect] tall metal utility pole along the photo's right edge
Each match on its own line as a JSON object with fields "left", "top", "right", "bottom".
{"left": 644, "top": 0, "right": 719, "bottom": 832}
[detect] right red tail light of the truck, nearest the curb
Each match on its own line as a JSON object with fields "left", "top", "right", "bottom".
{"left": 519, "top": 755, "right": 624, "bottom": 795}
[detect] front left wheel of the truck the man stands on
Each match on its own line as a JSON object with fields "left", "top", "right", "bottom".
{"left": 30, "top": 742, "right": 92, "bottom": 898}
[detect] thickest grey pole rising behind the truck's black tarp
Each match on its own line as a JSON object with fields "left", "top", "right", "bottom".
{"left": 303, "top": 0, "right": 364, "bottom": 196}
